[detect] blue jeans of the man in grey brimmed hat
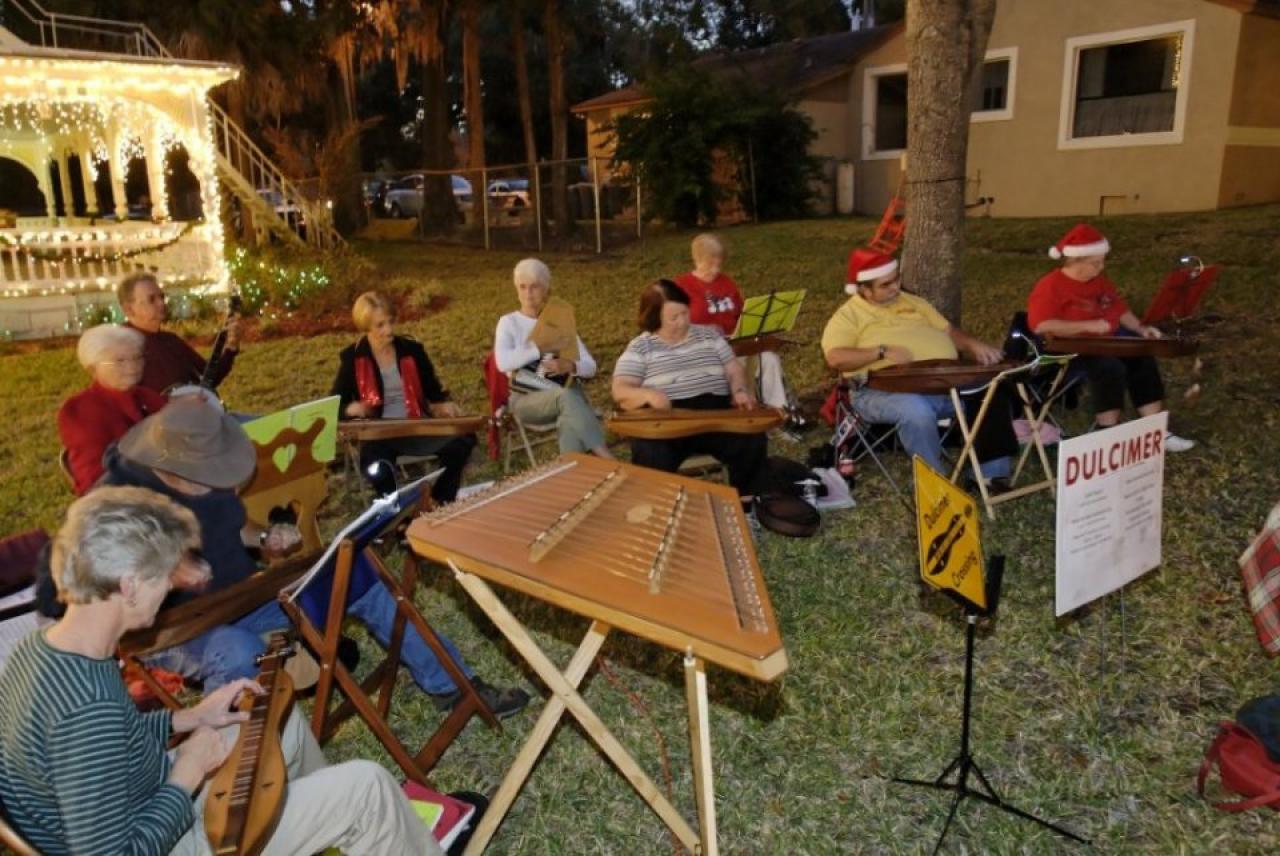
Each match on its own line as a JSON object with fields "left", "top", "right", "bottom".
{"left": 147, "top": 583, "right": 472, "bottom": 695}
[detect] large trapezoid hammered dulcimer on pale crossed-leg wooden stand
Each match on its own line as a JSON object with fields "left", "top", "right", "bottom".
{"left": 408, "top": 454, "right": 787, "bottom": 855}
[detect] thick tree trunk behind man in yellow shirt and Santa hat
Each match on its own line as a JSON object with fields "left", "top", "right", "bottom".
{"left": 902, "top": 0, "right": 996, "bottom": 324}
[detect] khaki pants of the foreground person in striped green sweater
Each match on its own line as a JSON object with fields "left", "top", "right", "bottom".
{"left": 173, "top": 710, "right": 444, "bottom": 856}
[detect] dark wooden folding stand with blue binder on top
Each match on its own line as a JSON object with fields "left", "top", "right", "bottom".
{"left": 280, "top": 473, "right": 500, "bottom": 784}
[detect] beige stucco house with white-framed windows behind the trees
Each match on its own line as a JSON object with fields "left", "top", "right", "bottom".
{"left": 575, "top": 0, "right": 1280, "bottom": 216}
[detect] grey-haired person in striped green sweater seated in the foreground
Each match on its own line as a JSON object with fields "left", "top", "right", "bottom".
{"left": 0, "top": 487, "right": 442, "bottom": 856}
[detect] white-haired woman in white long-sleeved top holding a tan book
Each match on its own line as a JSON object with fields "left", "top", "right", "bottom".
{"left": 493, "top": 258, "right": 613, "bottom": 458}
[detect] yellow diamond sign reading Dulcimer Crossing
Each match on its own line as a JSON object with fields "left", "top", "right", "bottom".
{"left": 913, "top": 456, "right": 987, "bottom": 609}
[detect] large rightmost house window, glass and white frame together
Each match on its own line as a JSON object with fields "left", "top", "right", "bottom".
{"left": 1061, "top": 22, "right": 1194, "bottom": 147}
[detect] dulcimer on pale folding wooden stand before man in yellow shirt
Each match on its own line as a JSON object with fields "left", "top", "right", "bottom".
{"left": 867, "top": 356, "right": 1070, "bottom": 519}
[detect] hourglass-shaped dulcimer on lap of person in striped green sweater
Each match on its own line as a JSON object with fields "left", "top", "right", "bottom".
{"left": 205, "top": 633, "right": 294, "bottom": 856}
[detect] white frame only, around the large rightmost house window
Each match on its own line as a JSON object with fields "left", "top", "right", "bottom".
{"left": 1057, "top": 18, "right": 1196, "bottom": 150}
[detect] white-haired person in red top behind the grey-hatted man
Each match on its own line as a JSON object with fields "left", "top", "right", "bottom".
{"left": 58, "top": 324, "right": 168, "bottom": 496}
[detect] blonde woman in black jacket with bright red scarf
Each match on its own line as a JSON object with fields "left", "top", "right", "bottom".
{"left": 329, "top": 292, "right": 476, "bottom": 503}
